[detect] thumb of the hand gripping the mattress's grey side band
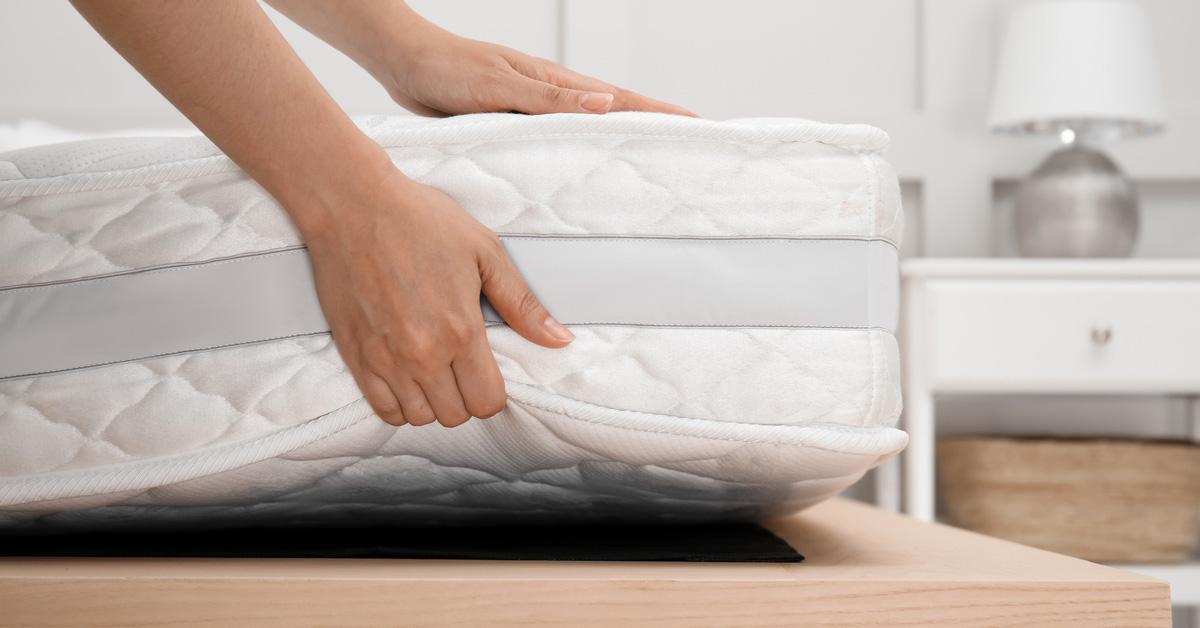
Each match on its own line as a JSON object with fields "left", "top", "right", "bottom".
{"left": 479, "top": 251, "right": 575, "bottom": 348}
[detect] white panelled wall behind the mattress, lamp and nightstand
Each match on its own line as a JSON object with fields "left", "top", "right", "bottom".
{"left": 0, "top": 0, "right": 1200, "bottom": 451}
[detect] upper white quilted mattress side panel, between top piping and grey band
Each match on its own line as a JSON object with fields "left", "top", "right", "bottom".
{"left": 0, "top": 137, "right": 899, "bottom": 287}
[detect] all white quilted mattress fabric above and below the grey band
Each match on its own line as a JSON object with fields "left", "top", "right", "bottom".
{"left": 0, "top": 114, "right": 905, "bottom": 526}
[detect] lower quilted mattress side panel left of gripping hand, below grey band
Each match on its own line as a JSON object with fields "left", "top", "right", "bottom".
{"left": 0, "top": 334, "right": 361, "bottom": 477}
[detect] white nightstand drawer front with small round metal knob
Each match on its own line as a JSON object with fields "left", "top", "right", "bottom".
{"left": 922, "top": 279, "right": 1200, "bottom": 391}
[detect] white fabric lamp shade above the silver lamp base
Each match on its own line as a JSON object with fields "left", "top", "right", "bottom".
{"left": 989, "top": 0, "right": 1165, "bottom": 139}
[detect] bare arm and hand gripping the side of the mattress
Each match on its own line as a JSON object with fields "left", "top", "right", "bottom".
{"left": 74, "top": 0, "right": 572, "bottom": 426}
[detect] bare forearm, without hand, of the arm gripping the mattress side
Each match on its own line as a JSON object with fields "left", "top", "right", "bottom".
{"left": 73, "top": 0, "right": 391, "bottom": 233}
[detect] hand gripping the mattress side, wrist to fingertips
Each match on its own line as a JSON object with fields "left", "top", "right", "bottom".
{"left": 305, "top": 165, "right": 575, "bottom": 427}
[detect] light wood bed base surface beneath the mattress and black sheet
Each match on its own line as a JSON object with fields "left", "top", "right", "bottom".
{"left": 0, "top": 500, "right": 1170, "bottom": 627}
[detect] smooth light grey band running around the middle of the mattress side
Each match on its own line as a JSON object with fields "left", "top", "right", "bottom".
{"left": 0, "top": 235, "right": 899, "bottom": 379}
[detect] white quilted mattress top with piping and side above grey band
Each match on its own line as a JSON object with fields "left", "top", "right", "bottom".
{"left": 0, "top": 113, "right": 902, "bottom": 287}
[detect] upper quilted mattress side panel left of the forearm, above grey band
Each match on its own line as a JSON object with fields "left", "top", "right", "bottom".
{"left": 0, "top": 172, "right": 302, "bottom": 287}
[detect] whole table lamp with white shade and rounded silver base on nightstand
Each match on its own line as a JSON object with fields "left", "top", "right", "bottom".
{"left": 989, "top": 0, "right": 1165, "bottom": 257}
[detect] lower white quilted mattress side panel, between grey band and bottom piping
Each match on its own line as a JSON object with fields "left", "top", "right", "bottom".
{"left": 0, "top": 327, "right": 899, "bottom": 477}
